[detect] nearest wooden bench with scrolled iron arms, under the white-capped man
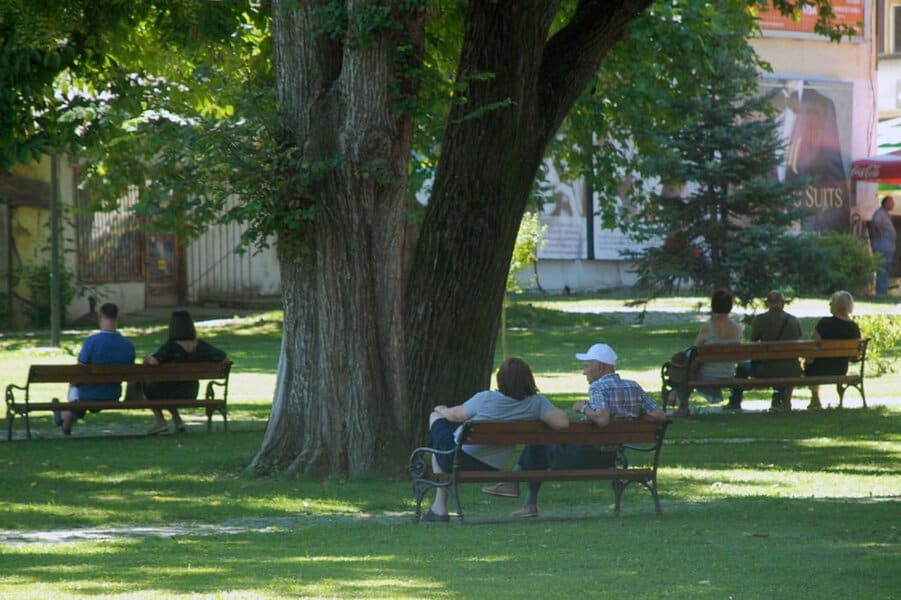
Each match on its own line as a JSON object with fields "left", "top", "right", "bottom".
{"left": 409, "top": 419, "right": 669, "bottom": 523}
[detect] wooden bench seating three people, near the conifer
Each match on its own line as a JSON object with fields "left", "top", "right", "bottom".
{"left": 660, "top": 339, "right": 869, "bottom": 408}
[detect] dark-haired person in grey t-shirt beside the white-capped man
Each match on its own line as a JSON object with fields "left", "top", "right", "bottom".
{"left": 422, "top": 358, "right": 569, "bottom": 522}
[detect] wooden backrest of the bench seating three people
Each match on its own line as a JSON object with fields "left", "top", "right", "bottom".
{"left": 694, "top": 340, "right": 869, "bottom": 363}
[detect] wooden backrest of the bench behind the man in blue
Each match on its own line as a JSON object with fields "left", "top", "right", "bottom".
{"left": 28, "top": 362, "right": 231, "bottom": 384}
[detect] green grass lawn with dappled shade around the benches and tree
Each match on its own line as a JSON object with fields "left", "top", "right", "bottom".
{"left": 0, "top": 297, "right": 901, "bottom": 598}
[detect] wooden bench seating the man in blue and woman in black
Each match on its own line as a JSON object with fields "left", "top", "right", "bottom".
{"left": 6, "top": 362, "right": 231, "bottom": 440}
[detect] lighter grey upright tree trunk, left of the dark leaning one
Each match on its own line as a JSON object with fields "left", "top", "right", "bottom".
{"left": 249, "top": 0, "right": 422, "bottom": 475}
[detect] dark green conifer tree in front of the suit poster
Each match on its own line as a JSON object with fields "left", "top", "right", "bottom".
{"left": 629, "top": 31, "right": 815, "bottom": 302}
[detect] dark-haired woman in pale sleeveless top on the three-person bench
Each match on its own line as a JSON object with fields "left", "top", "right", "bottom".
{"left": 676, "top": 288, "right": 742, "bottom": 417}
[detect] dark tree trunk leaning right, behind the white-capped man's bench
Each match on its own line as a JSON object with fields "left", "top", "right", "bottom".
{"left": 405, "top": 0, "right": 650, "bottom": 438}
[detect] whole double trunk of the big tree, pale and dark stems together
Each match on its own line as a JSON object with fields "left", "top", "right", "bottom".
{"left": 249, "top": 0, "right": 650, "bottom": 475}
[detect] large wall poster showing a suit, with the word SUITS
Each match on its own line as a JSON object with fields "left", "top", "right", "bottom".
{"left": 761, "top": 78, "right": 853, "bottom": 231}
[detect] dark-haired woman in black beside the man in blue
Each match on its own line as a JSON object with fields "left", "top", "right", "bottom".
{"left": 144, "top": 310, "right": 228, "bottom": 435}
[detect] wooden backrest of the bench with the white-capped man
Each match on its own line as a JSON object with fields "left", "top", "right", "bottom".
{"left": 460, "top": 419, "right": 667, "bottom": 446}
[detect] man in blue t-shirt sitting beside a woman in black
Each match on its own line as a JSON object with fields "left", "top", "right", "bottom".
{"left": 54, "top": 302, "right": 135, "bottom": 435}
